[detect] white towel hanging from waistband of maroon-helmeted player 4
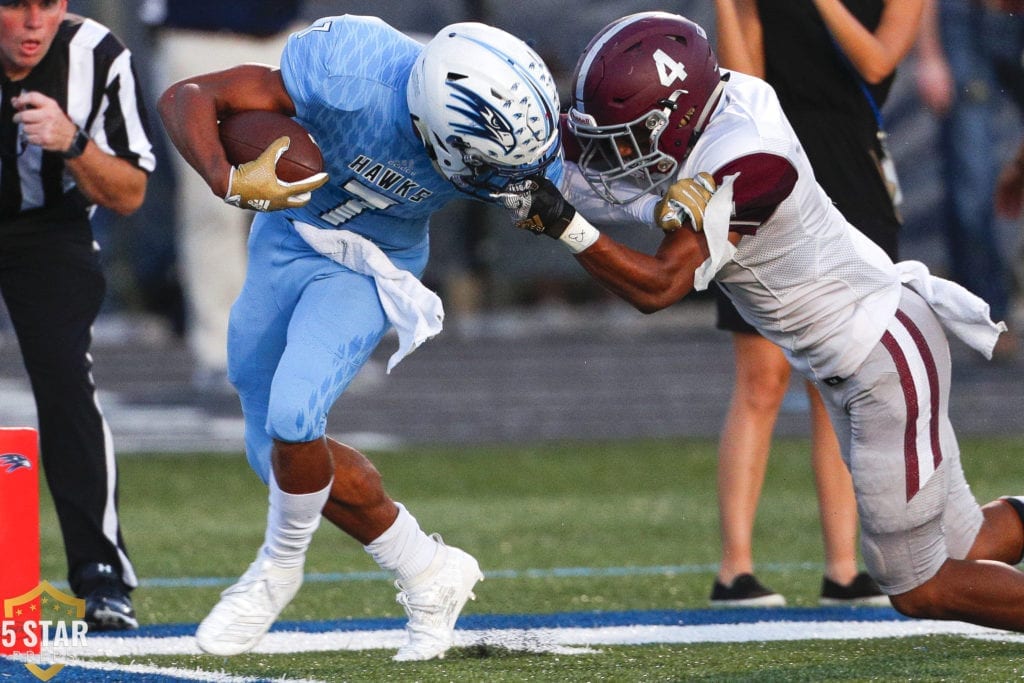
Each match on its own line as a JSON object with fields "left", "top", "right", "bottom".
{"left": 896, "top": 261, "right": 1007, "bottom": 358}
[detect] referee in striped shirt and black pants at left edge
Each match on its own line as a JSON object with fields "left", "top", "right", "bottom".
{"left": 0, "top": 0, "right": 156, "bottom": 630}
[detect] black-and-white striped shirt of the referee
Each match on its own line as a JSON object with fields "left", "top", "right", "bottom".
{"left": 0, "top": 14, "right": 156, "bottom": 239}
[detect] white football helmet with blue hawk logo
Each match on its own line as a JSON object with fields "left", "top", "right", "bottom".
{"left": 407, "top": 23, "right": 561, "bottom": 199}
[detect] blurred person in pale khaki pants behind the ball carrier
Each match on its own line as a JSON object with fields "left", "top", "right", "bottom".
{"left": 140, "top": 0, "right": 303, "bottom": 391}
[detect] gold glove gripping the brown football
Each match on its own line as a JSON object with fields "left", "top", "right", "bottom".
{"left": 224, "top": 135, "right": 328, "bottom": 211}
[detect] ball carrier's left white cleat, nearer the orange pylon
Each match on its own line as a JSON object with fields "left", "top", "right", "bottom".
{"left": 196, "top": 549, "right": 302, "bottom": 656}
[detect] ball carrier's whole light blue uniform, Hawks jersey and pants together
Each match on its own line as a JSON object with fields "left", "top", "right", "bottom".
{"left": 228, "top": 15, "right": 562, "bottom": 482}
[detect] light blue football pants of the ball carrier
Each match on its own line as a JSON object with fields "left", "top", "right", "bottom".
{"left": 227, "top": 213, "right": 429, "bottom": 482}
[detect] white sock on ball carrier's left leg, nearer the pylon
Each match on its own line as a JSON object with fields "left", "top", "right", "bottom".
{"left": 263, "top": 472, "right": 331, "bottom": 568}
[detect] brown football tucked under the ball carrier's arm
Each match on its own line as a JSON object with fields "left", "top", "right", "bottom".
{"left": 220, "top": 111, "right": 324, "bottom": 182}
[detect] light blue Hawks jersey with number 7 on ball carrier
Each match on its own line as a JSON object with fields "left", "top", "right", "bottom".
{"left": 281, "top": 15, "right": 458, "bottom": 252}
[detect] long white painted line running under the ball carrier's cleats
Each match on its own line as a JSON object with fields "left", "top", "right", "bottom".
{"left": 54, "top": 620, "right": 1024, "bottom": 663}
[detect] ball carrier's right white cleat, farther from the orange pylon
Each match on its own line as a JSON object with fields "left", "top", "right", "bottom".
{"left": 392, "top": 533, "right": 483, "bottom": 661}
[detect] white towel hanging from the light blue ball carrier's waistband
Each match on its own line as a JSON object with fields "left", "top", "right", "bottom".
{"left": 293, "top": 221, "right": 444, "bottom": 373}
